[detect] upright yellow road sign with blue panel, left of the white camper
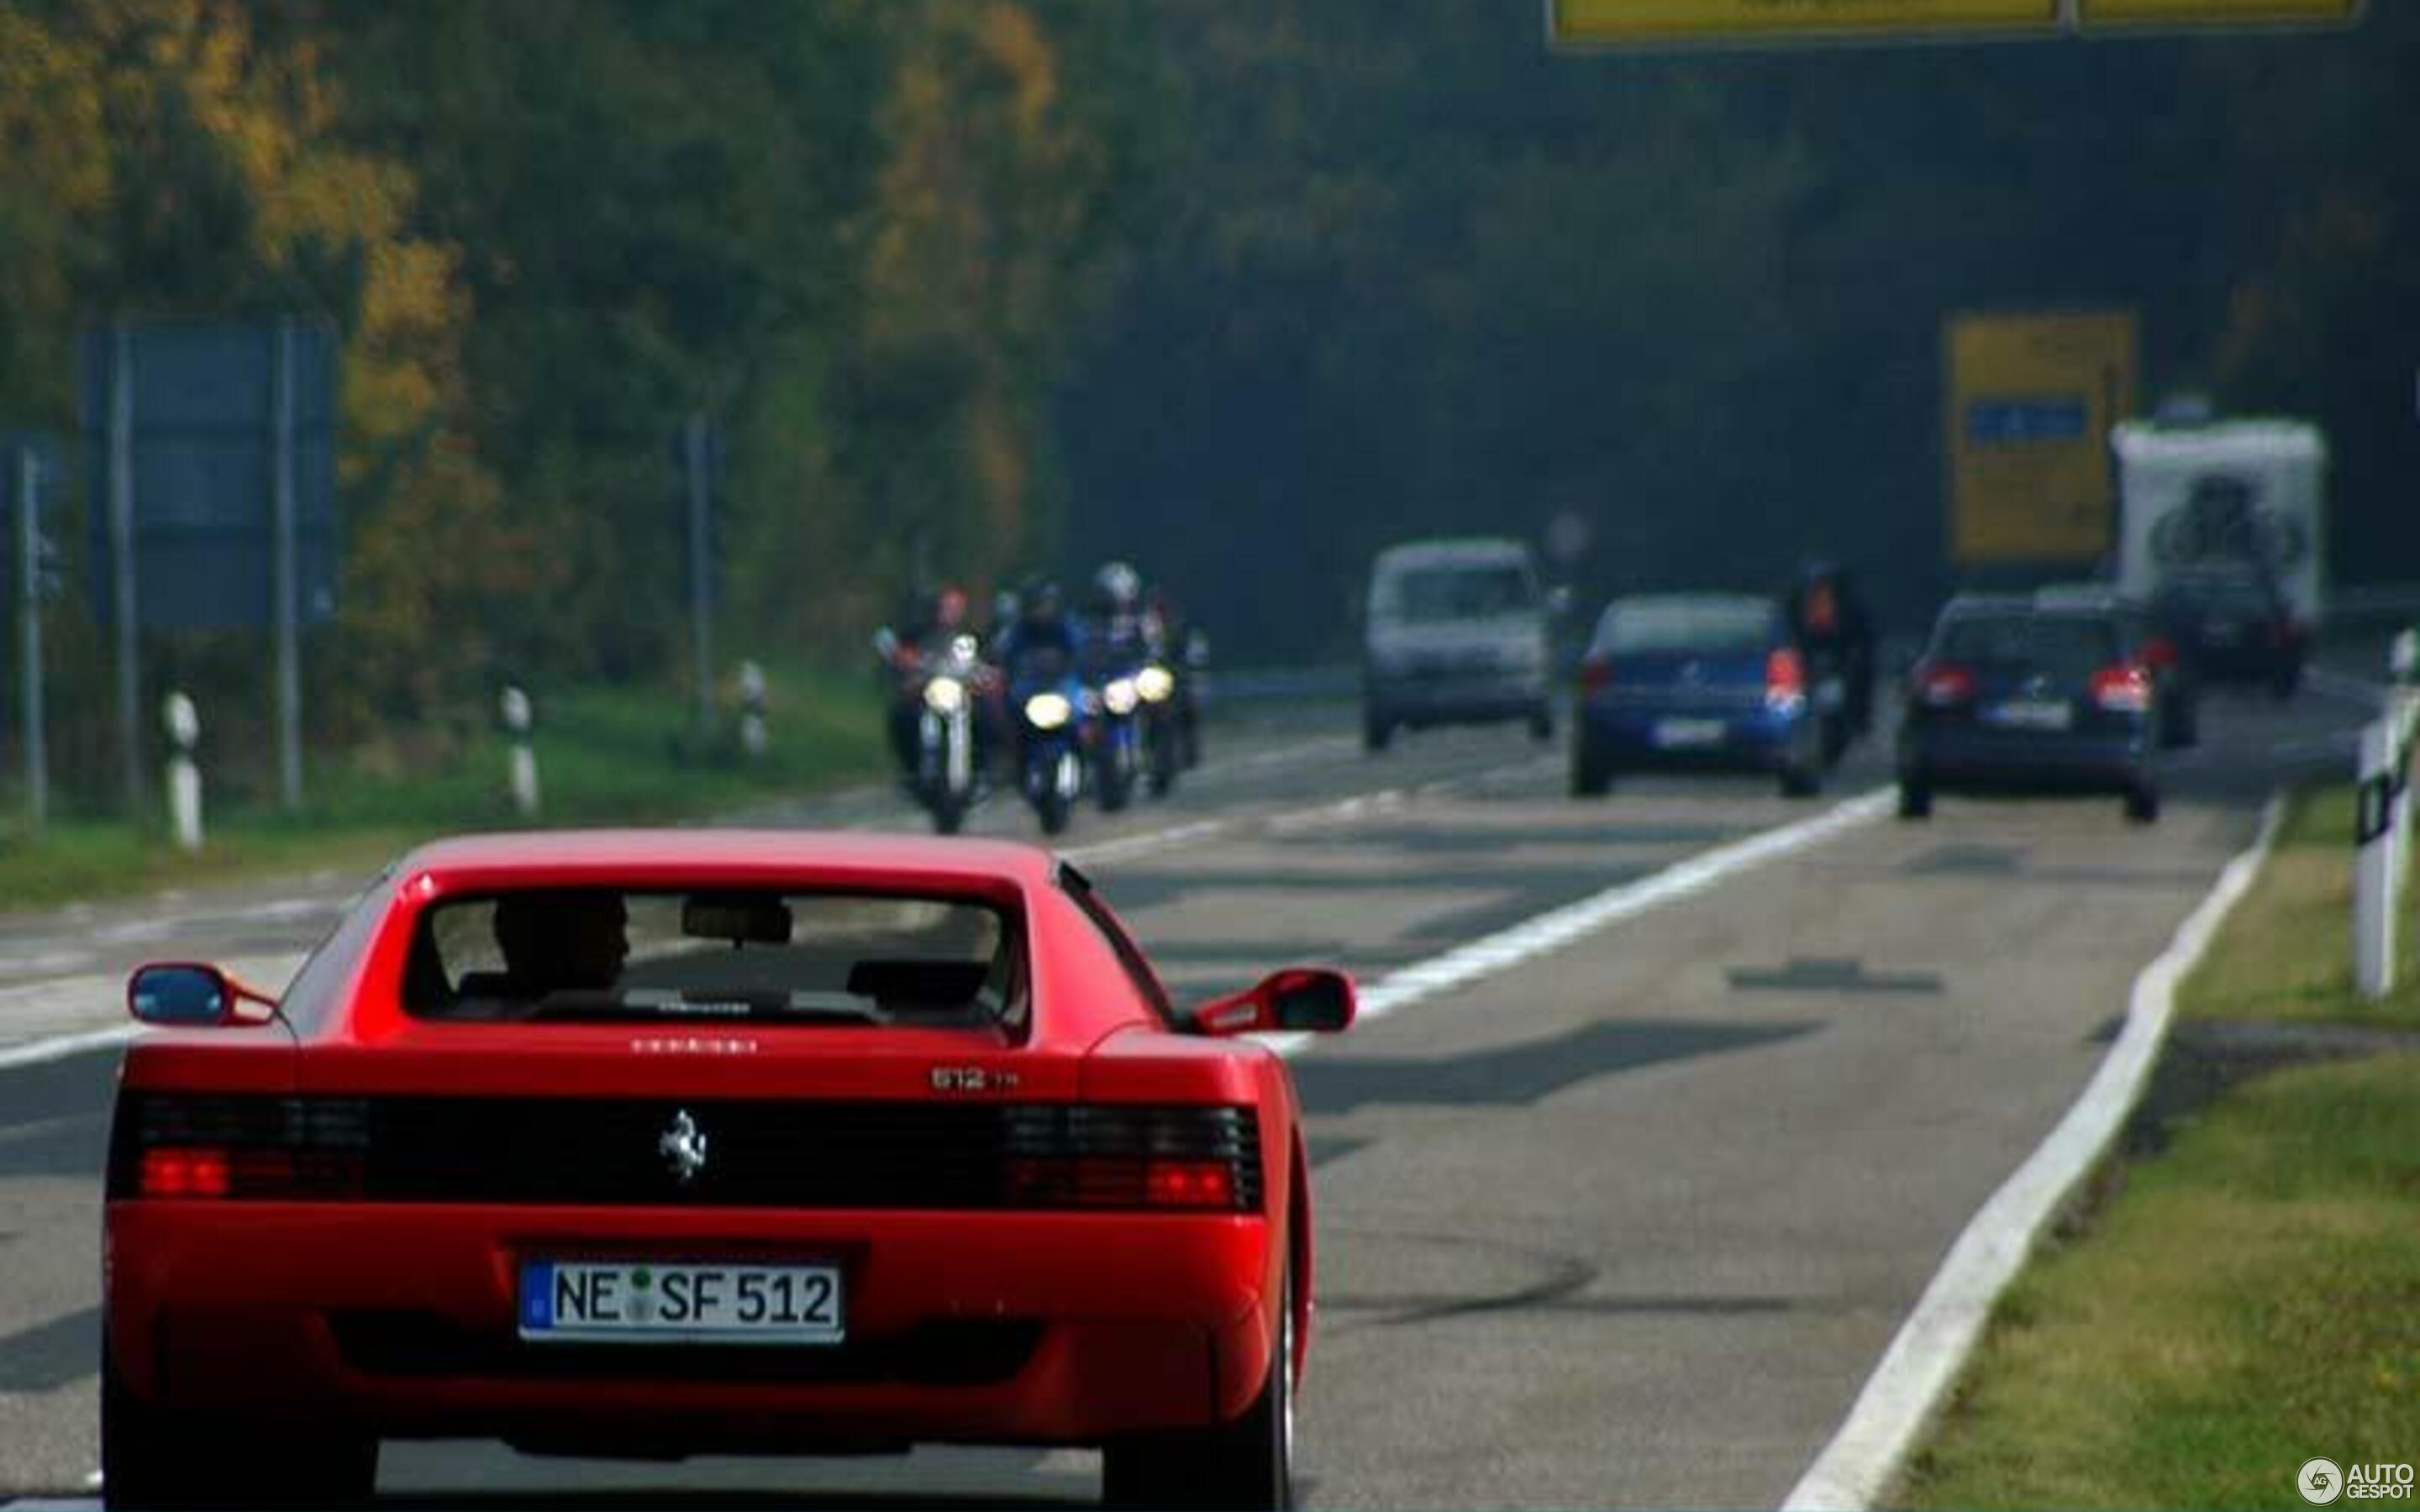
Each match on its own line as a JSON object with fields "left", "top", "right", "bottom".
{"left": 1941, "top": 310, "right": 2137, "bottom": 566}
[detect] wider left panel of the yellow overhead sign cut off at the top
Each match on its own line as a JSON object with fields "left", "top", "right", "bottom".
{"left": 1546, "top": 0, "right": 2060, "bottom": 46}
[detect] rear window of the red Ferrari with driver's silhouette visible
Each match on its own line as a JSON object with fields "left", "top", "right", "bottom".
{"left": 404, "top": 888, "right": 1026, "bottom": 1028}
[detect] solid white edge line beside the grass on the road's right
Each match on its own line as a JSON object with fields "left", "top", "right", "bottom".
{"left": 1781, "top": 798, "right": 2285, "bottom": 1512}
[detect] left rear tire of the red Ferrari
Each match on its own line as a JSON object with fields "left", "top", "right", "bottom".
{"left": 102, "top": 1342, "right": 377, "bottom": 1507}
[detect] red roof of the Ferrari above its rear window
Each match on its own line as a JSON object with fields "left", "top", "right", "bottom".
{"left": 394, "top": 827, "right": 1060, "bottom": 893}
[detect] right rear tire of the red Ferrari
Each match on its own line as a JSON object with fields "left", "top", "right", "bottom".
{"left": 1101, "top": 1265, "right": 1295, "bottom": 1512}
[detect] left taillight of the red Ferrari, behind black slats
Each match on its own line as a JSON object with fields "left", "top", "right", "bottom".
{"left": 109, "top": 1091, "right": 371, "bottom": 1202}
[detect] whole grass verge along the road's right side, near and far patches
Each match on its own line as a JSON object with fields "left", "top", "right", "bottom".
{"left": 1895, "top": 794, "right": 2420, "bottom": 1509}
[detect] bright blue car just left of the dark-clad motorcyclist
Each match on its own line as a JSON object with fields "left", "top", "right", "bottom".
{"left": 1570, "top": 593, "right": 1844, "bottom": 798}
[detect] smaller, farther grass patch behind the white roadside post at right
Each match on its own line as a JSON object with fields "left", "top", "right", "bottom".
{"left": 2178, "top": 784, "right": 2420, "bottom": 1028}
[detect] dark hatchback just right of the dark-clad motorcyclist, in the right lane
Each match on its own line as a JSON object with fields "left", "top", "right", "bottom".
{"left": 1900, "top": 597, "right": 2161, "bottom": 822}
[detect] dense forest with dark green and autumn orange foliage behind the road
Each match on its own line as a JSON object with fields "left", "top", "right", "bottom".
{"left": 0, "top": 0, "right": 2420, "bottom": 769}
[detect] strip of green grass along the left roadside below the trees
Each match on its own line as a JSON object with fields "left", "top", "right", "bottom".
{"left": 0, "top": 668, "right": 888, "bottom": 910}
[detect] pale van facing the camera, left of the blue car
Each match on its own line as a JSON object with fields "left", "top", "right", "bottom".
{"left": 1362, "top": 539, "right": 1554, "bottom": 750}
